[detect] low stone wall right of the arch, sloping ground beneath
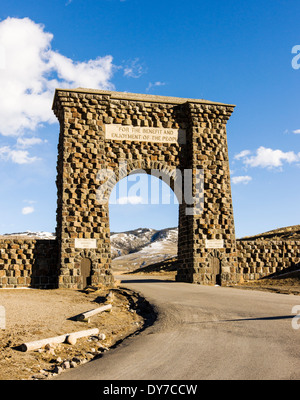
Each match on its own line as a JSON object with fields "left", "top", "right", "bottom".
{"left": 236, "top": 239, "right": 300, "bottom": 281}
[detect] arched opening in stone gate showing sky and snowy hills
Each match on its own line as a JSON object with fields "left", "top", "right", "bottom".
{"left": 109, "top": 169, "right": 179, "bottom": 274}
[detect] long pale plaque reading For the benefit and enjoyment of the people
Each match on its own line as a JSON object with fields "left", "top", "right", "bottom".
{"left": 105, "top": 124, "right": 186, "bottom": 144}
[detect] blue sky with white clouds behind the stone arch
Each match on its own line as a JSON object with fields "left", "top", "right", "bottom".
{"left": 0, "top": 0, "right": 300, "bottom": 237}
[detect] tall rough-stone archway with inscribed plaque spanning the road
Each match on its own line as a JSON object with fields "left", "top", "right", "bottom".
{"left": 53, "top": 89, "right": 237, "bottom": 288}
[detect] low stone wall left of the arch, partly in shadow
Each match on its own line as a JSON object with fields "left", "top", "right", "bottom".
{"left": 0, "top": 238, "right": 58, "bottom": 289}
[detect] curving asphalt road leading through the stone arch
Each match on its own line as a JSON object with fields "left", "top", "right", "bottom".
{"left": 56, "top": 276, "right": 300, "bottom": 380}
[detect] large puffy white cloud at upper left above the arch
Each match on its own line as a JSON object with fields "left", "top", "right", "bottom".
{"left": 0, "top": 18, "right": 114, "bottom": 136}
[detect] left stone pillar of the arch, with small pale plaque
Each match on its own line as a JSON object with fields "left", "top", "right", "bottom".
{"left": 54, "top": 92, "right": 113, "bottom": 289}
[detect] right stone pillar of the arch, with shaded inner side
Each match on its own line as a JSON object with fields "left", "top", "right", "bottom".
{"left": 176, "top": 102, "right": 237, "bottom": 284}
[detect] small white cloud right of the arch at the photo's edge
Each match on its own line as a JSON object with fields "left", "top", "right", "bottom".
{"left": 234, "top": 146, "right": 300, "bottom": 169}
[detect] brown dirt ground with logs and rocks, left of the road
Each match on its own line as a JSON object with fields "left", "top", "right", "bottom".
{"left": 0, "top": 282, "right": 154, "bottom": 380}
